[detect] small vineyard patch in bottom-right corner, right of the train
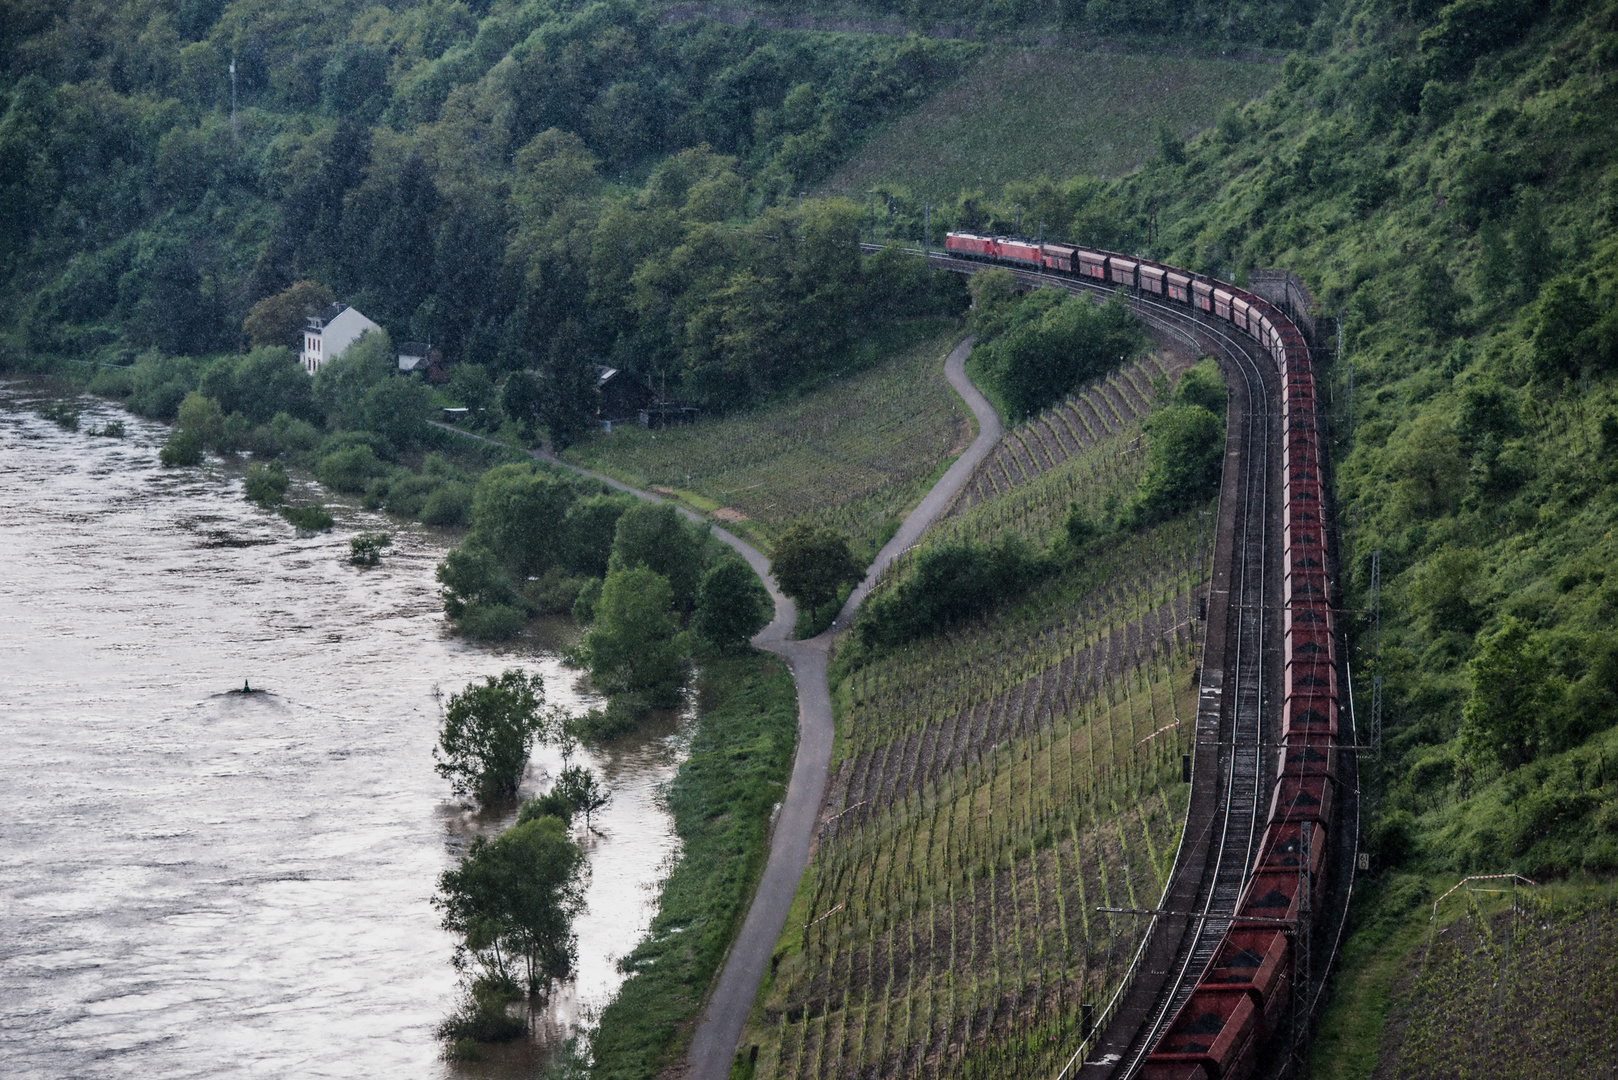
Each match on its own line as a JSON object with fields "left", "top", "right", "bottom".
{"left": 1385, "top": 889, "right": 1618, "bottom": 1080}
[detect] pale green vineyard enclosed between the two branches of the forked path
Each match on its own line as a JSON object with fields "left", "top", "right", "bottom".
{"left": 568, "top": 319, "right": 971, "bottom": 555}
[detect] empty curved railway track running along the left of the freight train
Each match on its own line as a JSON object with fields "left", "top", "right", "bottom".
{"left": 906, "top": 254, "right": 1281, "bottom": 1080}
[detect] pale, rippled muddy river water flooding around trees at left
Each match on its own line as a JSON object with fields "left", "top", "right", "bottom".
{"left": 0, "top": 382, "right": 686, "bottom": 1077}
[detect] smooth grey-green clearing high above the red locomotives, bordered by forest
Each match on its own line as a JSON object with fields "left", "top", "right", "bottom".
{"left": 824, "top": 49, "right": 1280, "bottom": 200}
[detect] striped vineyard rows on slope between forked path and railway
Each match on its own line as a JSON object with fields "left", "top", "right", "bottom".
{"left": 743, "top": 361, "right": 1212, "bottom": 1078}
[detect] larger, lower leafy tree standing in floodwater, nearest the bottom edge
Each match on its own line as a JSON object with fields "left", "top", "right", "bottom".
{"left": 434, "top": 814, "right": 584, "bottom": 994}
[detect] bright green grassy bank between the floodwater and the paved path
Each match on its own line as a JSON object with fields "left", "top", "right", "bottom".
{"left": 591, "top": 653, "right": 798, "bottom": 1080}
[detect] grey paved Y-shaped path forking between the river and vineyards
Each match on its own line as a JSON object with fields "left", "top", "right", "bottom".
{"left": 438, "top": 338, "right": 1002, "bottom": 1080}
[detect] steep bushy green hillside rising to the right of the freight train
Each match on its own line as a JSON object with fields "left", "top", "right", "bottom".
{"left": 893, "top": 0, "right": 1618, "bottom": 1077}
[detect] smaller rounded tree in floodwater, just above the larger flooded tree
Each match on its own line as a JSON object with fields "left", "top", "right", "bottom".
{"left": 432, "top": 669, "right": 545, "bottom": 806}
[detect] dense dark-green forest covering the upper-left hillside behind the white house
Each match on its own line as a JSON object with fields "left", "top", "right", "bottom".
{"left": 0, "top": 0, "right": 976, "bottom": 408}
